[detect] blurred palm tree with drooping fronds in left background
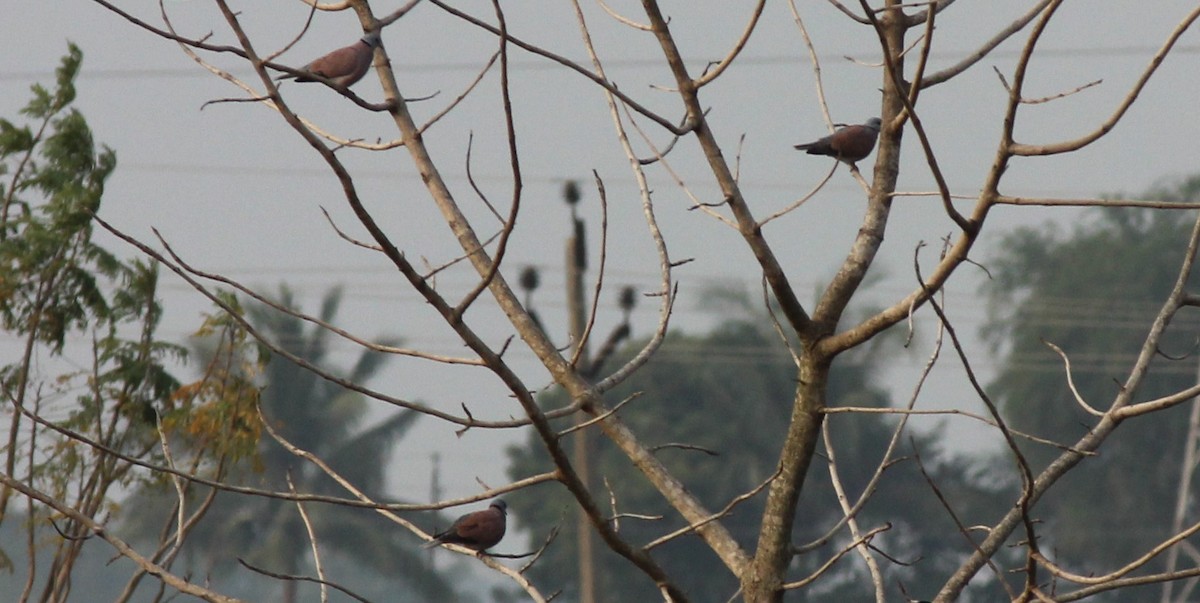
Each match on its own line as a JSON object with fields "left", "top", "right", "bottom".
{"left": 124, "top": 286, "right": 456, "bottom": 603}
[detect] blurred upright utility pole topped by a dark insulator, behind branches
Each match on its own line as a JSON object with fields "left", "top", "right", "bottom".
{"left": 563, "top": 180, "right": 596, "bottom": 603}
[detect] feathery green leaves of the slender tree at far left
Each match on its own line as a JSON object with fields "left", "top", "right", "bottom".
{"left": 0, "top": 39, "right": 184, "bottom": 458}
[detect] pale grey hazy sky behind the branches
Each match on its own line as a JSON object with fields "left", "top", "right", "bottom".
{"left": 7, "top": 0, "right": 1200, "bottom": 542}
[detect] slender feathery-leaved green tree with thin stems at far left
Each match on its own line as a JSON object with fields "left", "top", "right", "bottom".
{"left": 0, "top": 44, "right": 184, "bottom": 601}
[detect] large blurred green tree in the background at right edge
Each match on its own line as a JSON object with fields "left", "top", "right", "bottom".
{"left": 984, "top": 177, "right": 1200, "bottom": 601}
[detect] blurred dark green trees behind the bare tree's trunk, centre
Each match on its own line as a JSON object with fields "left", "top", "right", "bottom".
{"left": 506, "top": 307, "right": 996, "bottom": 602}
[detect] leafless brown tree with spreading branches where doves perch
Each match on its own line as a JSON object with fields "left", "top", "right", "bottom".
{"left": 6, "top": 0, "right": 1200, "bottom": 602}
